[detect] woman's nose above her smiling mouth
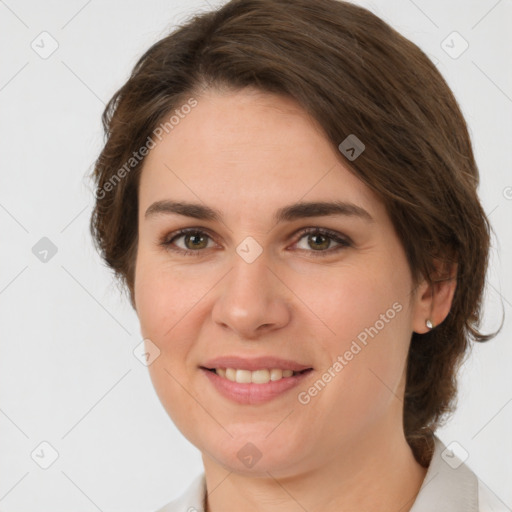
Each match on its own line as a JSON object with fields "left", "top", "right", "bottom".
{"left": 212, "top": 254, "right": 292, "bottom": 340}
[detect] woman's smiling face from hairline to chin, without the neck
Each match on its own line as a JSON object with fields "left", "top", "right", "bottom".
{"left": 135, "top": 90, "right": 425, "bottom": 475}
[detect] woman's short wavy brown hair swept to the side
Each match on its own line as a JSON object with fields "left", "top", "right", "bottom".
{"left": 90, "top": 0, "right": 496, "bottom": 465}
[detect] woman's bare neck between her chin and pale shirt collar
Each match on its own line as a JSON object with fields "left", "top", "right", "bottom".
{"left": 203, "top": 429, "right": 427, "bottom": 512}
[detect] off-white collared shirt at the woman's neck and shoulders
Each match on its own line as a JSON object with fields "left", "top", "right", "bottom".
{"left": 157, "top": 436, "right": 512, "bottom": 512}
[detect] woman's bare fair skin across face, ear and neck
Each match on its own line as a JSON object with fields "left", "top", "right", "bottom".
{"left": 134, "top": 89, "right": 455, "bottom": 512}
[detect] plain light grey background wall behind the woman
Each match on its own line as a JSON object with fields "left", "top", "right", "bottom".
{"left": 0, "top": 0, "right": 512, "bottom": 512}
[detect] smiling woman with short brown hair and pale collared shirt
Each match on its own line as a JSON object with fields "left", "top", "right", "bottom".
{"left": 91, "top": 0, "right": 500, "bottom": 512}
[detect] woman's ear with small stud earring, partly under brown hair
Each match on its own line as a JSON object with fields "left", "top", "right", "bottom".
{"left": 412, "top": 259, "right": 457, "bottom": 334}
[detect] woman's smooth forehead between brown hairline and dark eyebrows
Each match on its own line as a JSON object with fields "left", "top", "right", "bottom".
{"left": 139, "top": 90, "right": 378, "bottom": 220}
